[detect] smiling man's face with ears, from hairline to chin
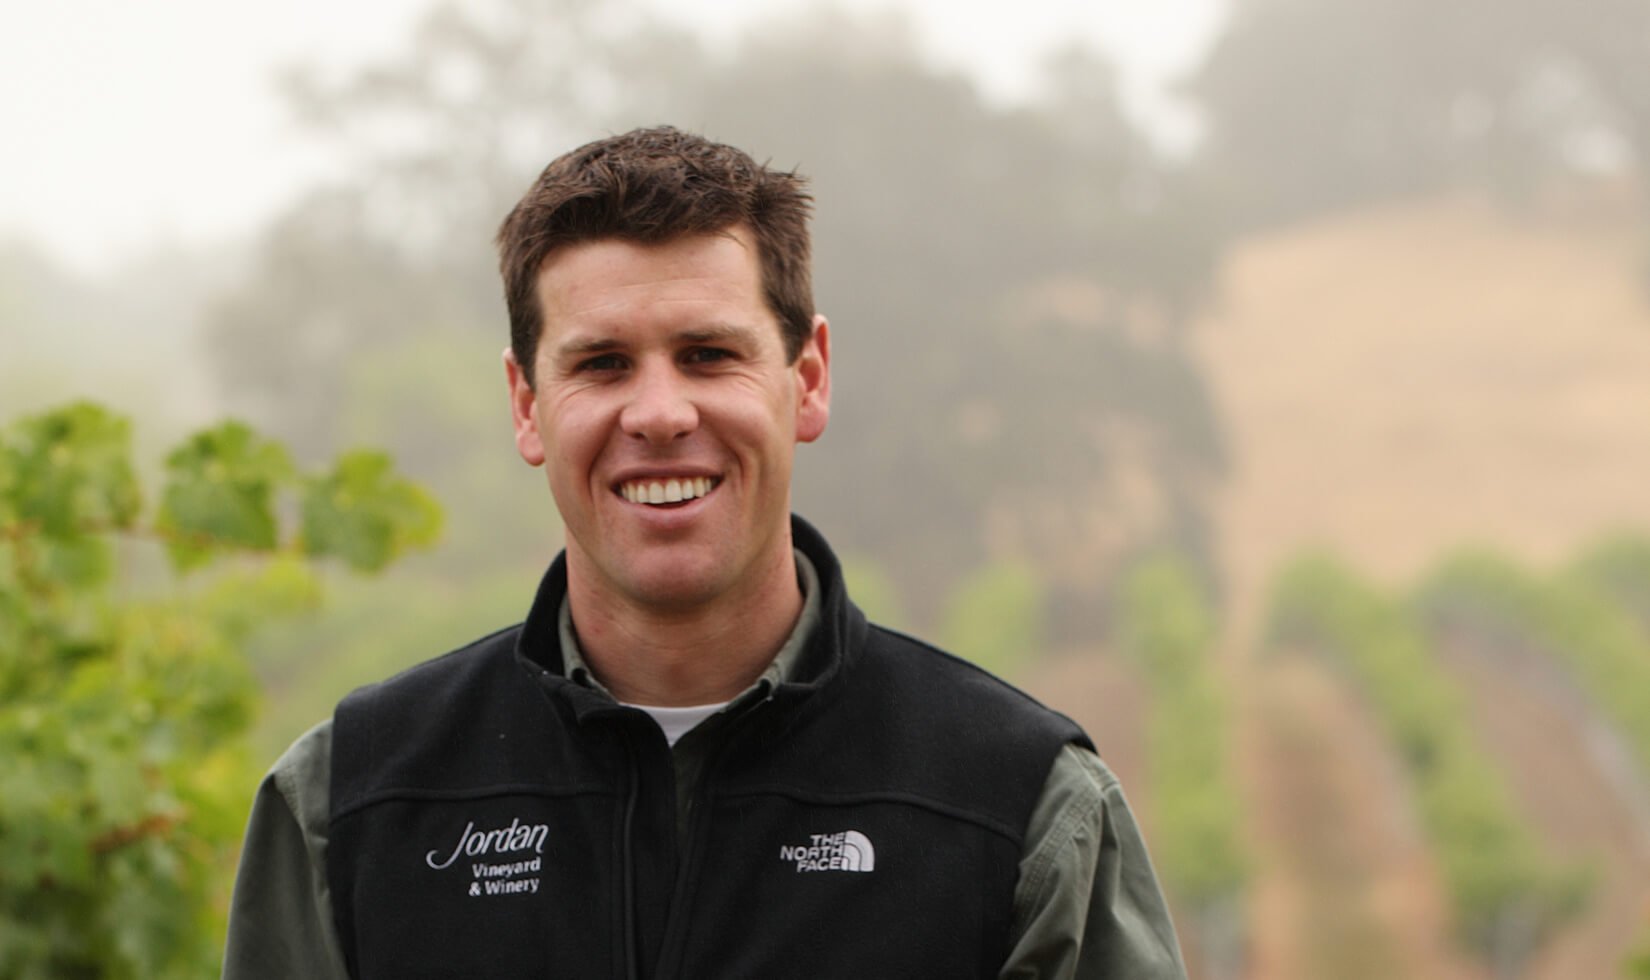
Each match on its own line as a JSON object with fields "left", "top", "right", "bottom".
{"left": 505, "top": 226, "right": 830, "bottom": 610}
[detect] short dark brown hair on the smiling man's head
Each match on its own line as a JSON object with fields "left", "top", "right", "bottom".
{"left": 497, "top": 125, "right": 813, "bottom": 384}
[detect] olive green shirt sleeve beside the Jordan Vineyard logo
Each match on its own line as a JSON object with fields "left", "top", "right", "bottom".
{"left": 223, "top": 721, "right": 348, "bottom": 980}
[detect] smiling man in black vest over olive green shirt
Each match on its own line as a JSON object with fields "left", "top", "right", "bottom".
{"left": 224, "top": 129, "right": 1183, "bottom": 978}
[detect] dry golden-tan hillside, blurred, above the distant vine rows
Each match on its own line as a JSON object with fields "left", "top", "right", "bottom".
{"left": 1198, "top": 185, "right": 1650, "bottom": 620}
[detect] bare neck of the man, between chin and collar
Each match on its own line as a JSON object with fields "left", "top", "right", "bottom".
{"left": 568, "top": 549, "right": 802, "bottom": 708}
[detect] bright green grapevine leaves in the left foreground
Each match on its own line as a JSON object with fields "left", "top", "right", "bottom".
{"left": 0, "top": 403, "right": 441, "bottom": 978}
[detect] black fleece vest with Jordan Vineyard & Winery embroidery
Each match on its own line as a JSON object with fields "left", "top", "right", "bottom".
{"left": 327, "top": 521, "right": 1086, "bottom": 980}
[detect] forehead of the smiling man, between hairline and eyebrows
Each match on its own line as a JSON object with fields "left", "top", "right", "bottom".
{"left": 536, "top": 226, "right": 762, "bottom": 330}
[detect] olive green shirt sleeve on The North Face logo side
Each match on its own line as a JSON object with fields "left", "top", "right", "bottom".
{"left": 998, "top": 746, "right": 1186, "bottom": 980}
